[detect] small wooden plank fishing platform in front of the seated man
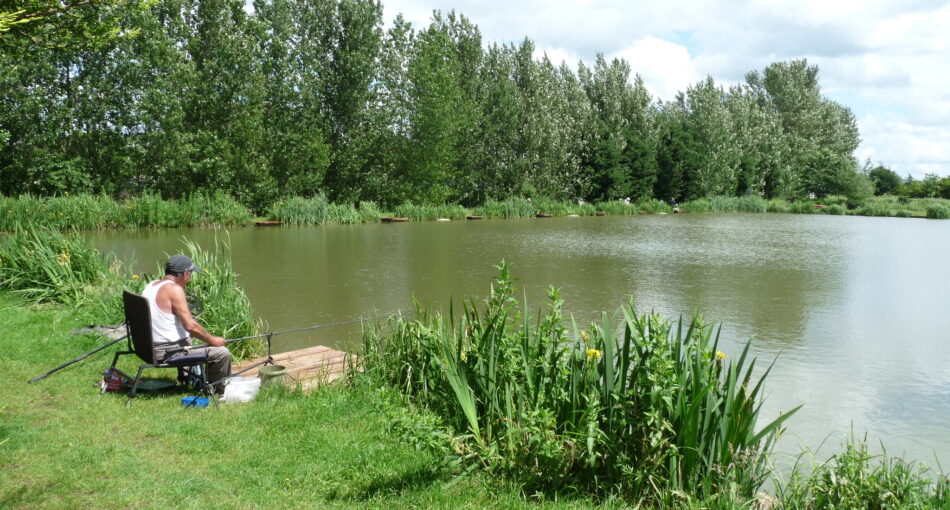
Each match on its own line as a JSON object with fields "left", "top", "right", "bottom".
{"left": 231, "top": 345, "right": 356, "bottom": 392}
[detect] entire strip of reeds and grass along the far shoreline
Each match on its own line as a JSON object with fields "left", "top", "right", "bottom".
{"left": 0, "top": 193, "right": 950, "bottom": 232}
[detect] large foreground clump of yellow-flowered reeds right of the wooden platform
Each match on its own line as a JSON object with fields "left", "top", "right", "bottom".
{"left": 364, "top": 263, "right": 797, "bottom": 505}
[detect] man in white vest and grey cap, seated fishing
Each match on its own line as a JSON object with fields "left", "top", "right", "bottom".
{"left": 142, "top": 254, "right": 231, "bottom": 394}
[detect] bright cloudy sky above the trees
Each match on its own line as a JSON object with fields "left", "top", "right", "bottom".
{"left": 382, "top": 0, "right": 950, "bottom": 179}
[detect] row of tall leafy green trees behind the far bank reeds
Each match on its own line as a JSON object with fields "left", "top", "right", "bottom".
{"left": 0, "top": 0, "right": 871, "bottom": 210}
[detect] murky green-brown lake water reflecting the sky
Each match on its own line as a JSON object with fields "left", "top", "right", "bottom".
{"left": 90, "top": 214, "right": 950, "bottom": 468}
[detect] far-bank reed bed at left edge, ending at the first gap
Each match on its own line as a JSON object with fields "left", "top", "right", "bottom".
{"left": 0, "top": 192, "right": 252, "bottom": 232}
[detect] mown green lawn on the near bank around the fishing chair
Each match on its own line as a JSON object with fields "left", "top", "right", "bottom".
{"left": 0, "top": 293, "right": 622, "bottom": 508}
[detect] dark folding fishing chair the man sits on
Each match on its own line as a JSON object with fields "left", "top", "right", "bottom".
{"left": 106, "top": 291, "right": 218, "bottom": 407}
